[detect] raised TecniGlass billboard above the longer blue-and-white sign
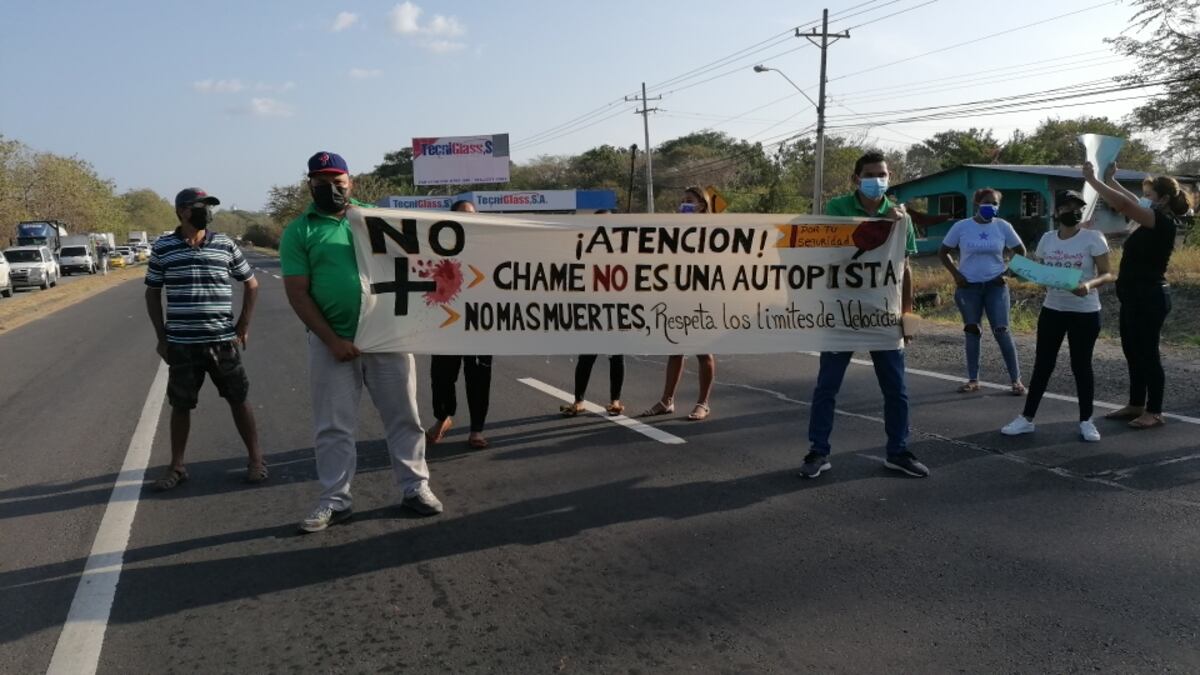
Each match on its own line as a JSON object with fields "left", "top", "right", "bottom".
{"left": 413, "top": 133, "right": 509, "bottom": 185}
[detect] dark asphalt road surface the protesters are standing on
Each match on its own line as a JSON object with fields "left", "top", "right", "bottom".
{"left": 0, "top": 249, "right": 1200, "bottom": 673}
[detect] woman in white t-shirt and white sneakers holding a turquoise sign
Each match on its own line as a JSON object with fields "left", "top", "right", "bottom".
{"left": 1000, "top": 190, "right": 1115, "bottom": 442}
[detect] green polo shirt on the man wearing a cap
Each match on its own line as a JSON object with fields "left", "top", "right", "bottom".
{"left": 280, "top": 199, "right": 372, "bottom": 340}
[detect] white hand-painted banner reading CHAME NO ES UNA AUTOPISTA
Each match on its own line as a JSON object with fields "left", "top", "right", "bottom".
{"left": 349, "top": 209, "right": 906, "bottom": 354}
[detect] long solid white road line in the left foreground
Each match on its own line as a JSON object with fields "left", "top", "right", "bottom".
{"left": 46, "top": 362, "right": 167, "bottom": 675}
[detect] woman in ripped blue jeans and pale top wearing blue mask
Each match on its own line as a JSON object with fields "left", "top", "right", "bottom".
{"left": 937, "top": 187, "right": 1025, "bottom": 396}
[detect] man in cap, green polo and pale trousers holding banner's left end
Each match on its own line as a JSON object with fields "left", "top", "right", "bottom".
{"left": 280, "top": 151, "right": 442, "bottom": 532}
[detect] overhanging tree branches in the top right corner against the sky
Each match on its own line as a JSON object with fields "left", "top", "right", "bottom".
{"left": 1108, "top": 0, "right": 1200, "bottom": 154}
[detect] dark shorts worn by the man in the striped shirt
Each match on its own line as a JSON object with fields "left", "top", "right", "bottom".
{"left": 167, "top": 340, "right": 250, "bottom": 410}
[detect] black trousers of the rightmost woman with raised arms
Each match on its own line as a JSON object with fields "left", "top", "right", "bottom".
{"left": 1117, "top": 283, "right": 1171, "bottom": 414}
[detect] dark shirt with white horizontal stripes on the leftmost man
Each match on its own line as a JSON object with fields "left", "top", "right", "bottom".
{"left": 146, "top": 228, "right": 254, "bottom": 345}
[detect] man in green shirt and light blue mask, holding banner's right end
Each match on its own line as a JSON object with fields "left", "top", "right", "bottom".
{"left": 800, "top": 153, "right": 929, "bottom": 478}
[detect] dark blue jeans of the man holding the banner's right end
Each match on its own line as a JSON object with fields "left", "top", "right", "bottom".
{"left": 809, "top": 350, "right": 908, "bottom": 456}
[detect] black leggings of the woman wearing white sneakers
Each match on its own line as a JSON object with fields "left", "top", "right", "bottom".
{"left": 1021, "top": 307, "right": 1100, "bottom": 422}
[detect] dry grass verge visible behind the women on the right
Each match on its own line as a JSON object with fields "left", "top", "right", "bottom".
{"left": 913, "top": 241, "right": 1200, "bottom": 346}
